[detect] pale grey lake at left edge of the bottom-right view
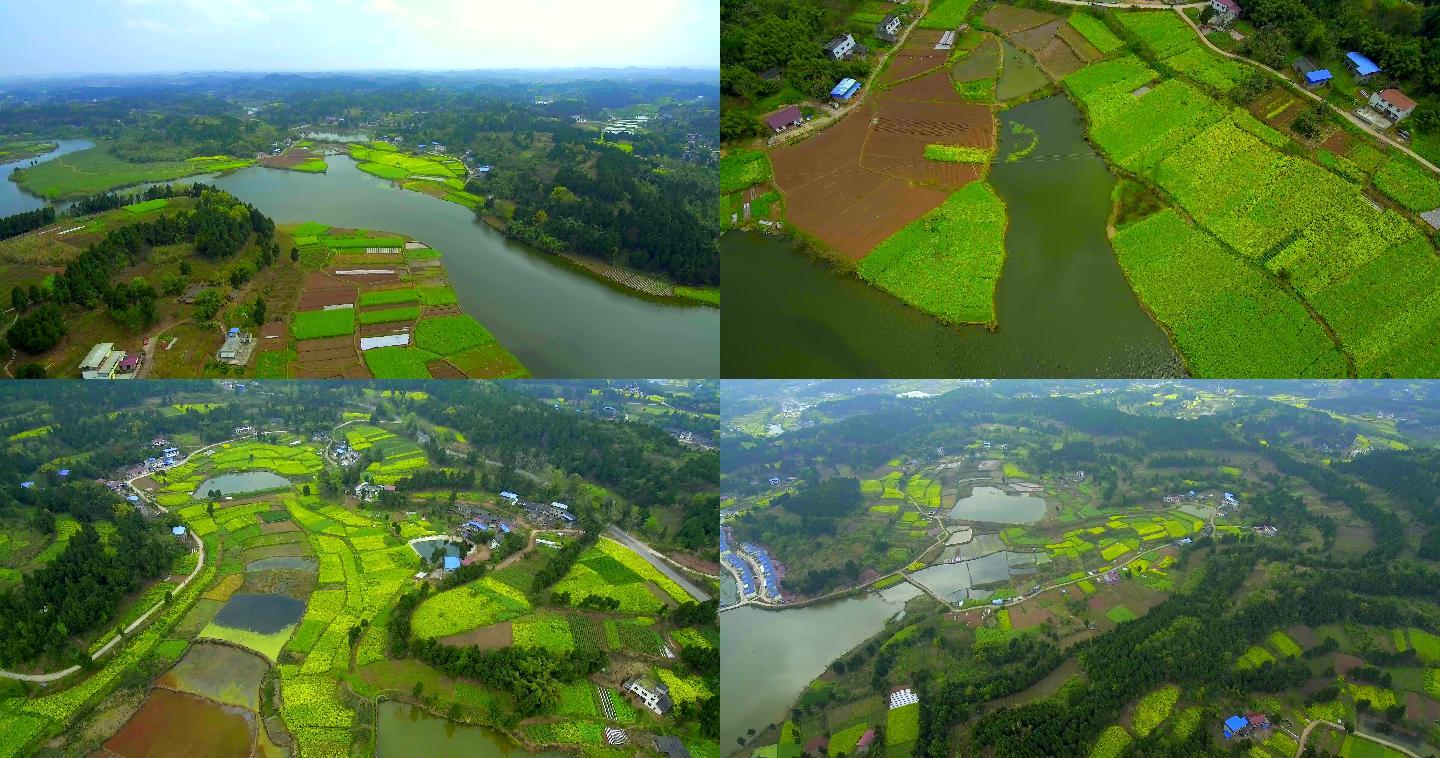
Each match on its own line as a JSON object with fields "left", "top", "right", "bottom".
{"left": 720, "top": 584, "right": 920, "bottom": 755}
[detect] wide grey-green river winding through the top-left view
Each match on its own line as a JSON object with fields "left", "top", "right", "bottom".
{"left": 0, "top": 140, "right": 720, "bottom": 378}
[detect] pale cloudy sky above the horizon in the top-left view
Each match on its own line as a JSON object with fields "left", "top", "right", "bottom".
{"left": 0, "top": 0, "right": 720, "bottom": 75}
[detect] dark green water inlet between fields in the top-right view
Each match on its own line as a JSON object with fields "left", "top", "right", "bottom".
{"left": 720, "top": 95, "right": 1184, "bottom": 378}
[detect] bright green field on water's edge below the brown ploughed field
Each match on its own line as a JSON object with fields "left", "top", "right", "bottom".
{"left": 858, "top": 182, "right": 1007, "bottom": 330}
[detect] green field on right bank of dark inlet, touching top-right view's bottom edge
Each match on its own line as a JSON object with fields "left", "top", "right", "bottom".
{"left": 1115, "top": 210, "right": 1345, "bottom": 378}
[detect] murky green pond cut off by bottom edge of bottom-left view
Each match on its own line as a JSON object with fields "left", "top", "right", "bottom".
{"left": 374, "top": 700, "right": 567, "bottom": 758}
